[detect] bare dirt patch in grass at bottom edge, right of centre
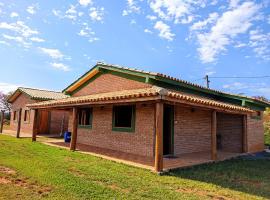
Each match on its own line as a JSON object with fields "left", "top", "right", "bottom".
{"left": 176, "top": 188, "right": 232, "bottom": 200}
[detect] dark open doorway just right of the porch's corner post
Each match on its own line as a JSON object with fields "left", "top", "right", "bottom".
{"left": 163, "top": 104, "right": 174, "bottom": 155}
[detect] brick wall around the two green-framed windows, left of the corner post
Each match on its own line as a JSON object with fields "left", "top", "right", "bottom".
{"left": 69, "top": 104, "right": 155, "bottom": 156}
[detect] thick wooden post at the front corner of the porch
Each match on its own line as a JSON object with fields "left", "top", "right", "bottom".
{"left": 155, "top": 102, "right": 164, "bottom": 172}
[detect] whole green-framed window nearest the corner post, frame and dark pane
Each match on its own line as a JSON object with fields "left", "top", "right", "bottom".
{"left": 113, "top": 105, "right": 135, "bottom": 132}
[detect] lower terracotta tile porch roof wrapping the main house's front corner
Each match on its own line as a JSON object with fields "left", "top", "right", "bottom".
{"left": 27, "top": 86, "right": 253, "bottom": 112}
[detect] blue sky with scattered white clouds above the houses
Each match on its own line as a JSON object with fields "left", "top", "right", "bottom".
{"left": 0, "top": 0, "right": 270, "bottom": 98}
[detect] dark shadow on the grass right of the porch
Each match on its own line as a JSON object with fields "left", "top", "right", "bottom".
{"left": 168, "top": 158, "right": 270, "bottom": 199}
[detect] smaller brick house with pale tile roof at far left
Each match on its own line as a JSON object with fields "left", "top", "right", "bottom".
{"left": 8, "top": 87, "right": 69, "bottom": 137}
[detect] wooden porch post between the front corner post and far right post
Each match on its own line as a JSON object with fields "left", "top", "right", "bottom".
{"left": 211, "top": 110, "right": 217, "bottom": 160}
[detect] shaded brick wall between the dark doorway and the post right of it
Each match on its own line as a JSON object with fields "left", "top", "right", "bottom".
{"left": 174, "top": 106, "right": 211, "bottom": 155}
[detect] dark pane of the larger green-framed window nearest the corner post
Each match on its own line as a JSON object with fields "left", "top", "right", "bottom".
{"left": 114, "top": 106, "right": 133, "bottom": 128}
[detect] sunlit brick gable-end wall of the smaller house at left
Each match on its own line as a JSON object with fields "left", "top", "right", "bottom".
{"left": 10, "top": 94, "right": 36, "bottom": 133}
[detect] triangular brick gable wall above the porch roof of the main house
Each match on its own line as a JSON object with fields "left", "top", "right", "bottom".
{"left": 72, "top": 74, "right": 151, "bottom": 96}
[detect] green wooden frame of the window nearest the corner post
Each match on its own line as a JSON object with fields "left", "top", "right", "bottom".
{"left": 112, "top": 105, "right": 136, "bottom": 133}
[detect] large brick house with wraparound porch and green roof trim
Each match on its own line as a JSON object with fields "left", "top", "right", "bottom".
{"left": 27, "top": 63, "right": 270, "bottom": 171}
